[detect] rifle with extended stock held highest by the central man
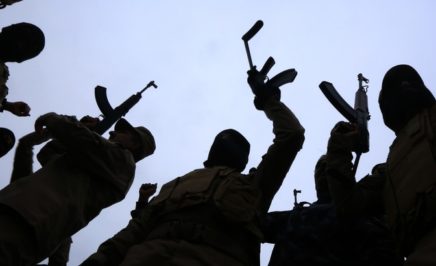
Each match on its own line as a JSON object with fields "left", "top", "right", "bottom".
{"left": 242, "top": 20, "right": 297, "bottom": 87}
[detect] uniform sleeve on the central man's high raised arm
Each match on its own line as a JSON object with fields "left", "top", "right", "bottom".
{"left": 254, "top": 99, "right": 304, "bottom": 213}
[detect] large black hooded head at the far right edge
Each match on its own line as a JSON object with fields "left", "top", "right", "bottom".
{"left": 378, "top": 65, "right": 436, "bottom": 133}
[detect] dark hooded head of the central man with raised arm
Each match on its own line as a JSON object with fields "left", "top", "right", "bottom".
{"left": 203, "top": 129, "right": 250, "bottom": 172}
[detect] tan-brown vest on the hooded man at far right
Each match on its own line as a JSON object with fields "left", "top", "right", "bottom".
{"left": 384, "top": 103, "right": 436, "bottom": 255}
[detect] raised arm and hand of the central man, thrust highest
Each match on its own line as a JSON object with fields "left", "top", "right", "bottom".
{"left": 247, "top": 69, "right": 304, "bottom": 213}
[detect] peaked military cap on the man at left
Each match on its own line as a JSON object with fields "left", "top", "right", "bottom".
{"left": 115, "top": 118, "right": 156, "bottom": 162}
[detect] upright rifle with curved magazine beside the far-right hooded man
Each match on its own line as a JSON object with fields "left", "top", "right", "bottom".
{"left": 319, "top": 73, "right": 370, "bottom": 176}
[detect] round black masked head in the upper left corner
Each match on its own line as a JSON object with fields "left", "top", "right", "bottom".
{"left": 0, "top": 22, "right": 45, "bottom": 63}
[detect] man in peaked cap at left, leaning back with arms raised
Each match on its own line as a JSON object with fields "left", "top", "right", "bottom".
{"left": 0, "top": 113, "right": 155, "bottom": 266}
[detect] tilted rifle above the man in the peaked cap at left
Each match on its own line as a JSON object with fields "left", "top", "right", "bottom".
{"left": 94, "top": 81, "right": 157, "bottom": 135}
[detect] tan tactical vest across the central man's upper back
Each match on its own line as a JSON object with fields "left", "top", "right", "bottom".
{"left": 149, "top": 167, "right": 261, "bottom": 236}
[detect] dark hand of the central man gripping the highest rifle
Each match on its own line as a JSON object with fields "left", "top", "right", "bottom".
{"left": 247, "top": 68, "right": 281, "bottom": 110}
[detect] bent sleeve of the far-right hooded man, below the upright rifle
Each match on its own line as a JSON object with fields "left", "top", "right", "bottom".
{"left": 326, "top": 132, "right": 386, "bottom": 216}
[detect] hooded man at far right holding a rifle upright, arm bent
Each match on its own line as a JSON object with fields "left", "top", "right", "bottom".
{"left": 327, "top": 65, "right": 436, "bottom": 265}
